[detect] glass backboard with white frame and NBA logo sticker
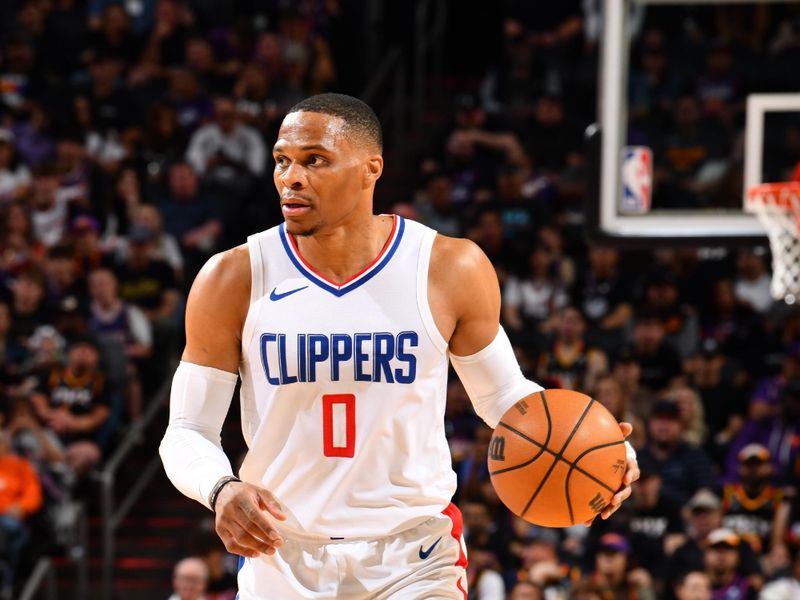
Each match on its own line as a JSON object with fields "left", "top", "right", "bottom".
{"left": 587, "top": 0, "right": 800, "bottom": 246}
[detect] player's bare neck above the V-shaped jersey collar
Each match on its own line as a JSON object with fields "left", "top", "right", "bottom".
{"left": 294, "top": 215, "right": 394, "bottom": 282}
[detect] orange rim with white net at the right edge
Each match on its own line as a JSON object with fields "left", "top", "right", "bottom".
{"left": 745, "top": 181, "right": 800, "bottom": 304}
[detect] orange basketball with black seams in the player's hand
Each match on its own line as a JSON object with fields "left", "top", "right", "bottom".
{"left": 488, "top": 390, "right": 626, "bottom": 527}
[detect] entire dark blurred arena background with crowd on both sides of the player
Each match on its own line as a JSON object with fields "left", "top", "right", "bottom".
{"left": 0, "top": 0, "right": 800, "bottom": 600}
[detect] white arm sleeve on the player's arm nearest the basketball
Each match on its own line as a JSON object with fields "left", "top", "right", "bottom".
{"left": 450, "top": 327, "right": 544, "bottom": 429}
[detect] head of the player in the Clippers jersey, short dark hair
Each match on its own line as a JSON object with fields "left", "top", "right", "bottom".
{"left": 273, "top": 94, "right": 383, "bottom": 236}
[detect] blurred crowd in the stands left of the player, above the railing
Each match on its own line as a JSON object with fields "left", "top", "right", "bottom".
{"left": 0, "top": 0, "right": 346, "bottom": 598}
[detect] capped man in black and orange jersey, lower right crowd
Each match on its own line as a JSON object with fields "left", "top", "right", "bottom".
{"left": 722, "top": 444, "right": 791, "bottom": 553}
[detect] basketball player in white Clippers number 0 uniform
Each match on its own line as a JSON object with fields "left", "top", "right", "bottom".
{"left": 161, "top": 94, "right": 638, "bottom": 600}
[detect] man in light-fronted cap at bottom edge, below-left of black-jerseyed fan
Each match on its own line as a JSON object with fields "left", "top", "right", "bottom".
{"left": 703, "top": 528, "right": 763, "bottom": 600}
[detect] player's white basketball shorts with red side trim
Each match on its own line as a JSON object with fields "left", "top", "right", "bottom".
{"left": 231, "top": 504, "right": 467, "bottom": 600}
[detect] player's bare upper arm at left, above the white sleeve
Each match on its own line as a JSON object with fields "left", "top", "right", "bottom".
{"left": 181, "top": 248, "right": 250, "bottom": 373}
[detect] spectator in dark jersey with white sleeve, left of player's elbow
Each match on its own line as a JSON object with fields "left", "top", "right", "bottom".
{"left": 89, "top": 268, "right": 153, "bottom": 420}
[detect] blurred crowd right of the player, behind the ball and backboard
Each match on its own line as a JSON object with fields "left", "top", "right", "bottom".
{"left": 395, "top": 1, "right": 800, "bottom": 600}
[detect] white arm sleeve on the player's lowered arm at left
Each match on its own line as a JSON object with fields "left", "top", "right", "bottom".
{"left": 159, "top": 361, "right": 237, "bottom": 508}
